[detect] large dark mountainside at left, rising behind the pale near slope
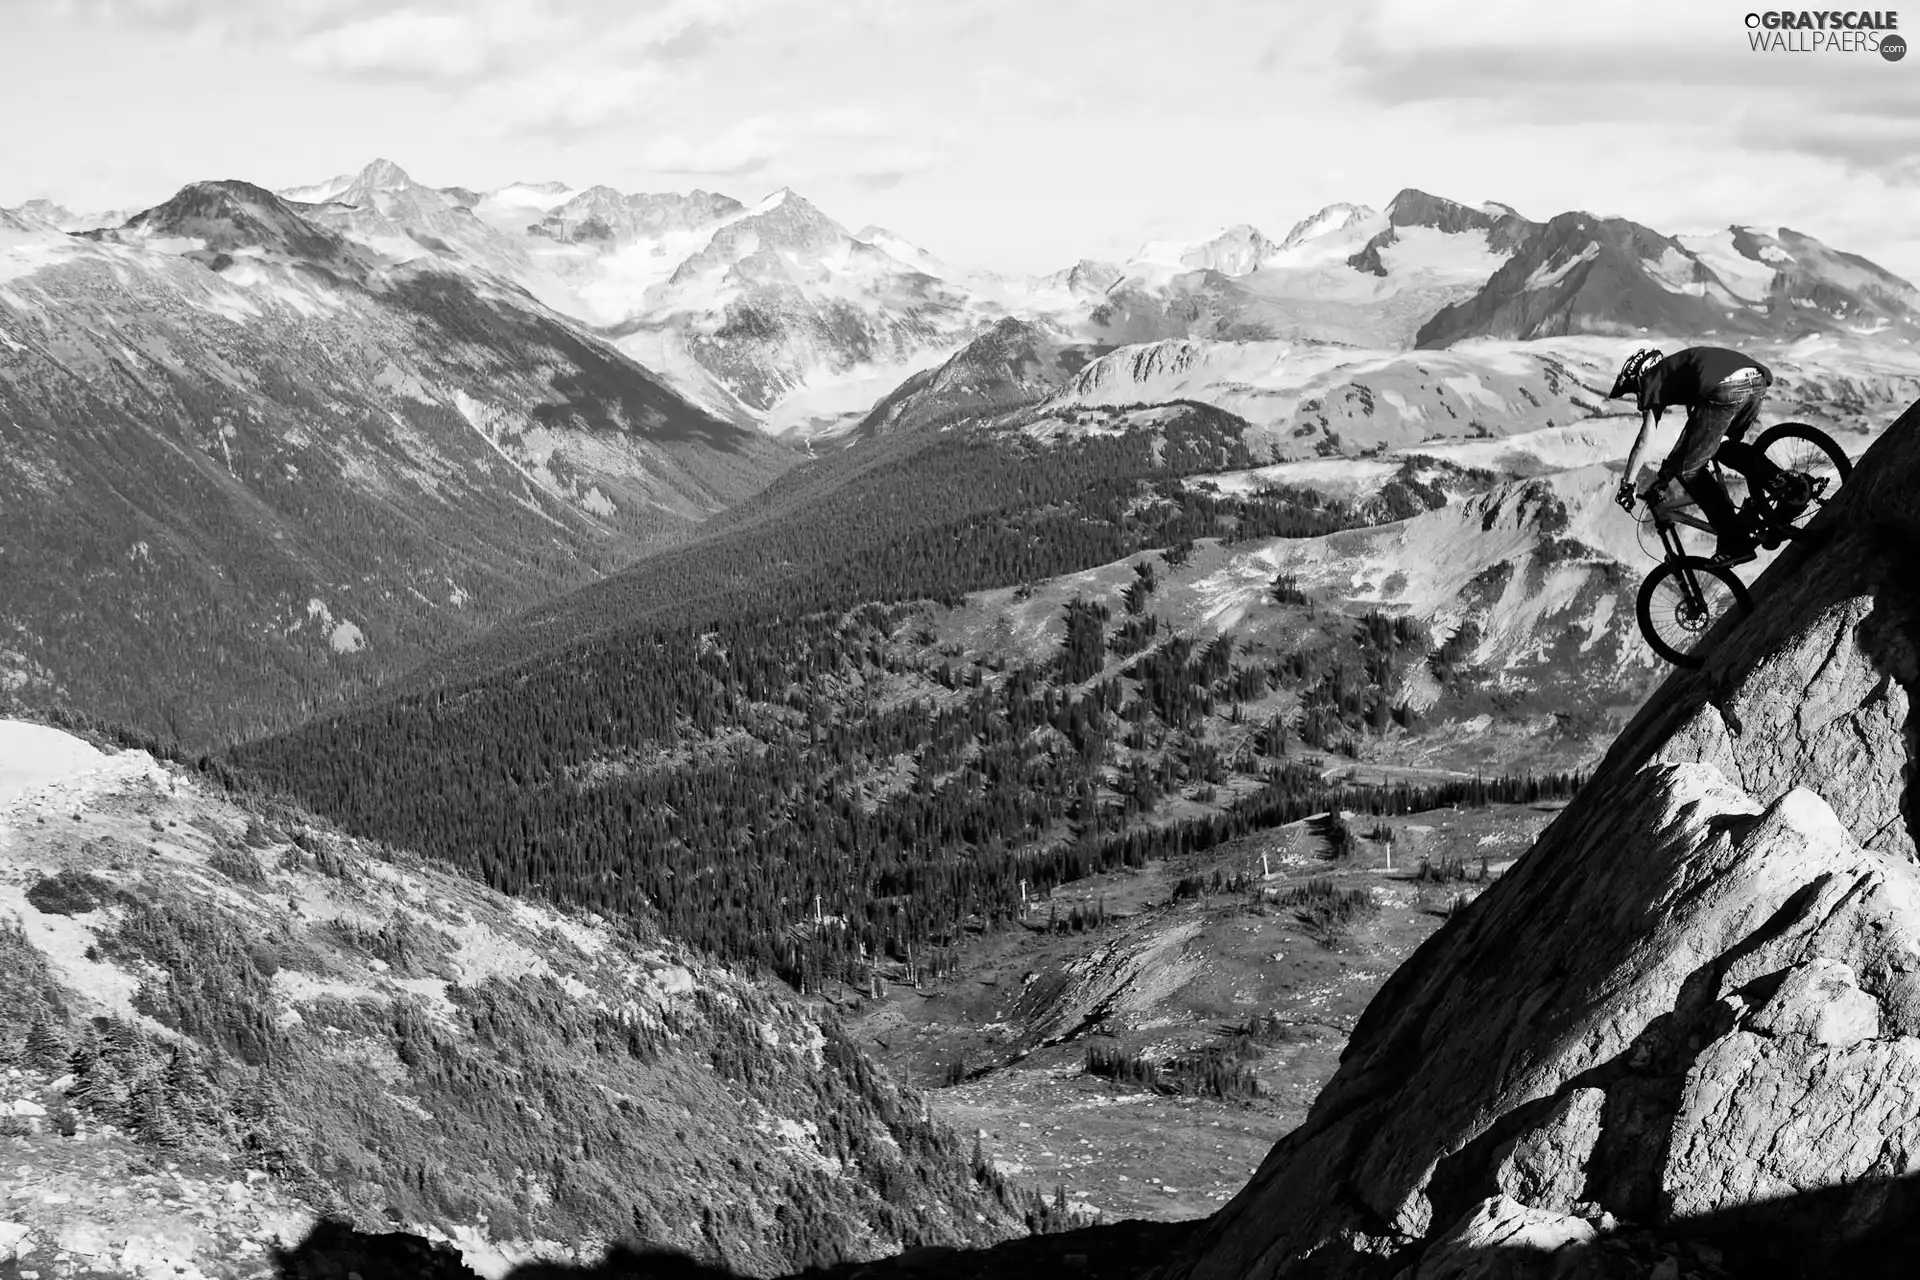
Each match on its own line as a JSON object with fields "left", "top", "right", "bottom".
{"left": 0, "top": 182, "right": 791, "bottom": 745}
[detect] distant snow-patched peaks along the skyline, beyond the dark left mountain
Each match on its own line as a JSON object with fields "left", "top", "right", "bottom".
{"left": 37, "top": 161, "right": 1920, "bottom": 445}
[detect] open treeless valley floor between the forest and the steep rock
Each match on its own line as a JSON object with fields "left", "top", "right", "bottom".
{"left": 843, "top": 802, "right": 1561, "bottom": 1221}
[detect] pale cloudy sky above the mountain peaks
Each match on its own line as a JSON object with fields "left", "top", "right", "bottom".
{"left": 0, "top": 0, "right": 1920, "bottom": 280}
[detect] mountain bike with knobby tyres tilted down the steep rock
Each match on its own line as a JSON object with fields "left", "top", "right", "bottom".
{"left": 1636, "top": 422, "right": 1853, "bottom": 668}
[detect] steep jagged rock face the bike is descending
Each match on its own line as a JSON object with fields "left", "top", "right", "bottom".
{"left": 1165, "top": 405, "right": 1920, "bottom": 1280}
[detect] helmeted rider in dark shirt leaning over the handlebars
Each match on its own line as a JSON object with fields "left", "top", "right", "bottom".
{"left": 1607, "top": 347, "right": 1774, "bottom": 564}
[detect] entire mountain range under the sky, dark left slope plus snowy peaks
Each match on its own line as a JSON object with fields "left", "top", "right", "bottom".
{"left": 0, "top": 161, "right": 1920, "bottom": 741}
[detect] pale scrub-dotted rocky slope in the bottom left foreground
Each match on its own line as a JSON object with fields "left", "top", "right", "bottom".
{"left": 0, "top": 722, "right": 1025, "bottom": 1280}
